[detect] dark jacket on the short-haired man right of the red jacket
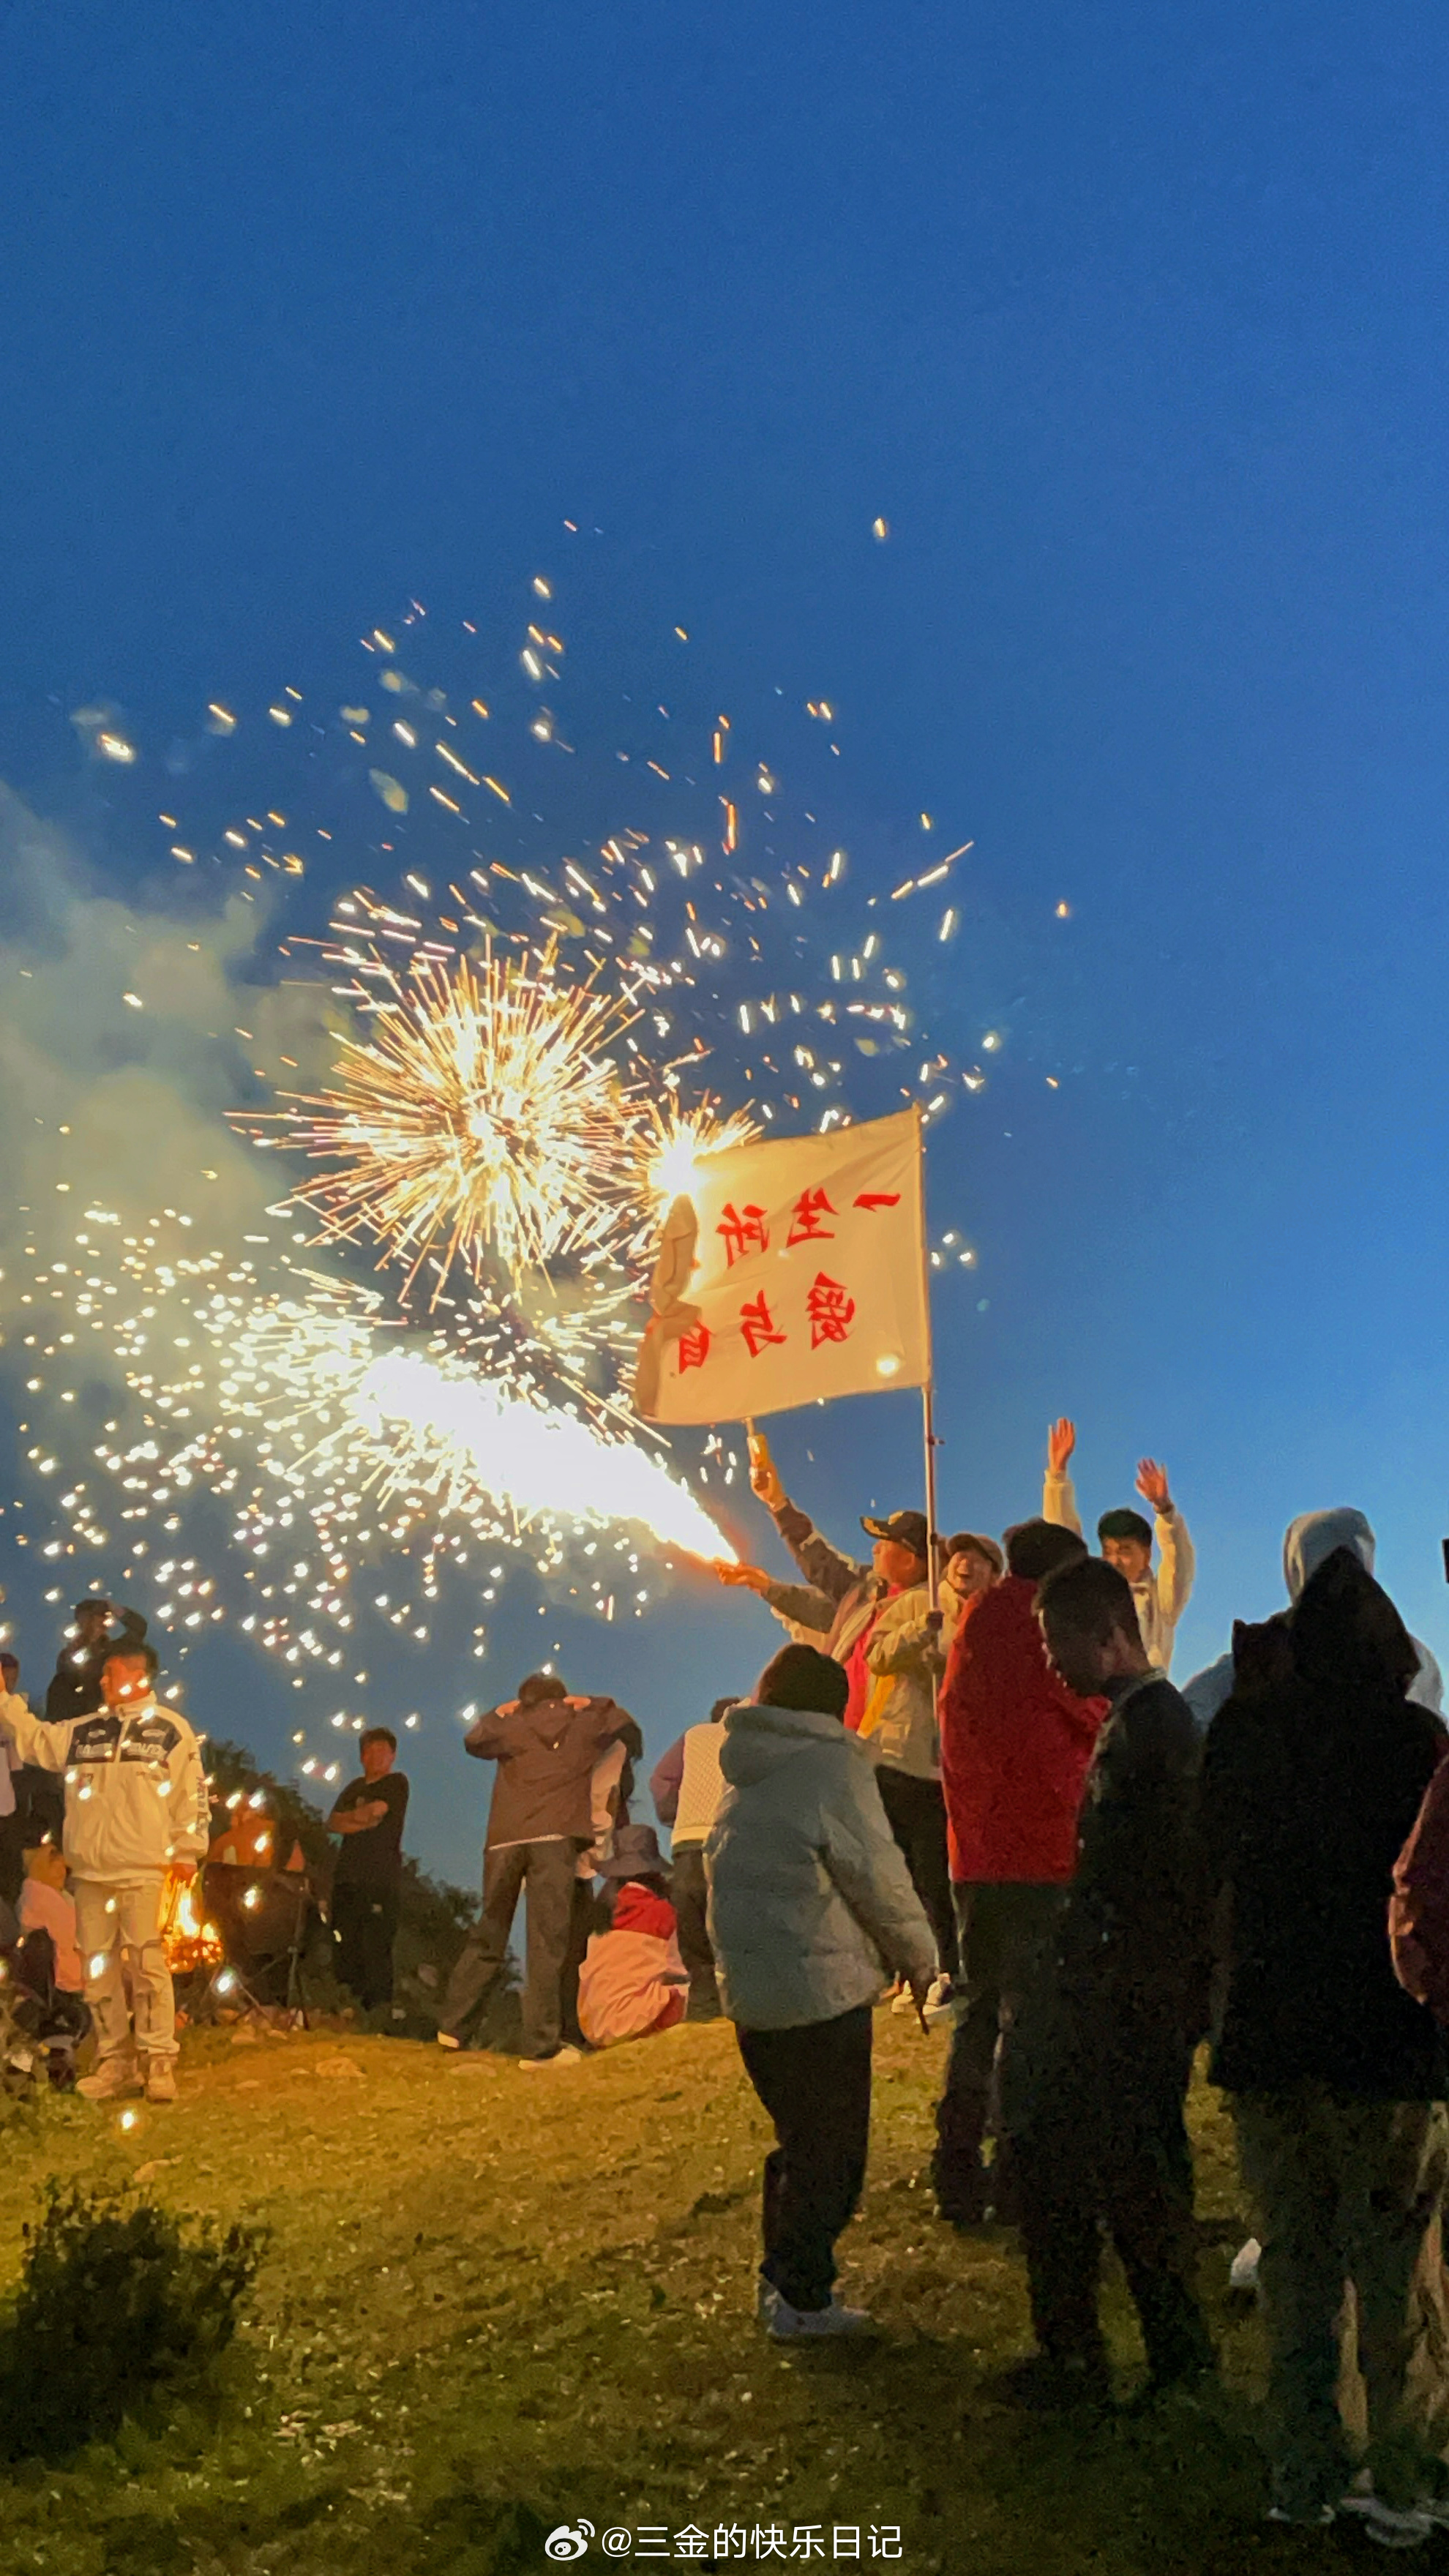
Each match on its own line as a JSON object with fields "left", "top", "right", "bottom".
{"left": 1046, "top": 1669, "right": 1207, "bottom": 2043}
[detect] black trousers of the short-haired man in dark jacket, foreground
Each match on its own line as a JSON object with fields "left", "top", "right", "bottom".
{"left": 1014, "top": 2025, "right": 1212, "bottom": 2380}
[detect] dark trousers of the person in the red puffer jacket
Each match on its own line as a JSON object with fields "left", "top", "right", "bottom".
{"left": 931, "top": 1881, "right": 1068, "bottom": 2225}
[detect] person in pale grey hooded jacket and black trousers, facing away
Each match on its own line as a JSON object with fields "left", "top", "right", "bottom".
{"left": 704, "top": 1646, "right": 936, "bottom": 2342}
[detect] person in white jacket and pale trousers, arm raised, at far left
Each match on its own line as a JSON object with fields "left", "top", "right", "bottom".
{"left": 0, "top": 1641, "right": 211, "bottom": 2102}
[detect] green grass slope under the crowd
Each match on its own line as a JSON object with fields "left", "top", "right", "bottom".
{"left": 0, "top": 2015, "right": 1299, "bottom": 2576}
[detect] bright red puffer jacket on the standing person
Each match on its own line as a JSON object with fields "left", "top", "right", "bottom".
{"left": 938, "top": 1574, "right": 1106, "bottom": 1886}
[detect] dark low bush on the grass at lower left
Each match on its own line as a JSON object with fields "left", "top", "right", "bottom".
{"left": 0, "top": 2174, "right": 266, "bottom": 2457}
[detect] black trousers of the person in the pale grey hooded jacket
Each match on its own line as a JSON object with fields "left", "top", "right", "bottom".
{"left": 735, "top": 2004, "right": 872, "bottom": 2308}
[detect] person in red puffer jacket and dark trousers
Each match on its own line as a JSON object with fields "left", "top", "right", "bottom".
{"left": 931, "top": 1520, "right": 1106, "bottom": 2225}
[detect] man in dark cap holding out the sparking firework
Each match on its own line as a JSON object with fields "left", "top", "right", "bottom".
{"left": 716, "top": 1437, "right": 956, "bottom": 2012}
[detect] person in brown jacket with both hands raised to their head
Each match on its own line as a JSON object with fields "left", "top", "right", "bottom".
{"left": 438, "top": 1671, "right": 642, "bottom": 2069}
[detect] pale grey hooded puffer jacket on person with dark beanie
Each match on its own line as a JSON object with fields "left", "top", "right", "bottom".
{"left": 704, "top": 1703, "right": 936, "bottom": 2030}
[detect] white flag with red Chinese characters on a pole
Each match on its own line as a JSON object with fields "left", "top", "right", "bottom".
{"left": 634, "top": 1110, "right": 931, "bottom": 1422}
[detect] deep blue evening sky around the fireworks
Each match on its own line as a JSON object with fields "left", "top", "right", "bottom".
{"left": 0, "top": 0, "right": 1449, "bottom": 1871}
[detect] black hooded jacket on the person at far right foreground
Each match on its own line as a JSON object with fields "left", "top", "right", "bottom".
{"left": 1202, "top": 1549, "right": 1444, "bottom": 2102}
